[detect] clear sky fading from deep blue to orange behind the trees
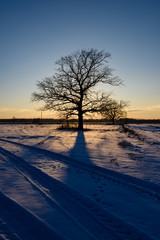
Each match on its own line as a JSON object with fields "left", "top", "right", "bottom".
{"left": 0, "top": 0, "right": 160, "bottom": 118}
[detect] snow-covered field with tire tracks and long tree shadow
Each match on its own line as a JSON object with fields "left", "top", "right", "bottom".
{"left": 0, "top": 124, "right": 160, "bottom": 240}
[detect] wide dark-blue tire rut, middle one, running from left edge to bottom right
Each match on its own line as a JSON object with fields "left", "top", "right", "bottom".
{"left": 0, "top": 144, "right": 155, "bottom": 240}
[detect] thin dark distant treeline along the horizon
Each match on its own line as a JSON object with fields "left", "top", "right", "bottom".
{"left": 0, "top": 118, "right": 160, "bottom": 124}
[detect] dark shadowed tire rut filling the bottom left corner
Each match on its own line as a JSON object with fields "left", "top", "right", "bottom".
{"left": 0, "top": 192, "right": 64, "bottom": 240}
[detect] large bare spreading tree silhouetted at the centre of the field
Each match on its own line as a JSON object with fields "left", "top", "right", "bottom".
{"left": 32, "top": 49, "right": 122, "bottom": 130}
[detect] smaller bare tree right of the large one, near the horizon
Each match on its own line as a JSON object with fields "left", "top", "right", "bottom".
{"left": 100, "top": 98, "right": 129, "bottom": 124}
